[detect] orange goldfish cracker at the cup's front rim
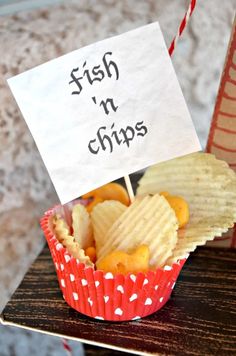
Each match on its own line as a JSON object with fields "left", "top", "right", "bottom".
{"left": 97, "top": 245, "right": 149, "bottom": 275}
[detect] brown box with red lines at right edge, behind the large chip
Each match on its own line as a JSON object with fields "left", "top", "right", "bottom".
{"left": 206, "top": 17, "right": 236, "bottom": 248}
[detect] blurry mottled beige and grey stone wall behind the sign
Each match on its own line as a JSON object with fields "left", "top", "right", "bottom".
{"left": 0, "top": 0, "right": 235, "bottom": 354}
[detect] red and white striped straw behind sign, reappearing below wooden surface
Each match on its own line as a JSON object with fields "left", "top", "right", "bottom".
{"left": 62, "top": 0, "right": 197, "bottom": 356}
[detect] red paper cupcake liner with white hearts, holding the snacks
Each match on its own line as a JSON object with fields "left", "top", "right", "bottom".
{"left": 41, "top": 202, "right": 186, "bottom": 321}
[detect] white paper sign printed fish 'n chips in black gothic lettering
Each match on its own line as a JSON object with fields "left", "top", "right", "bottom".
{"left": 8, "top": 23, "right": 201, "bottom": 204}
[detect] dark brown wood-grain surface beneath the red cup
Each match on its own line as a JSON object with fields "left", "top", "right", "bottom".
{"left": 1, "top": 247, "right": 236, "bottom": 355}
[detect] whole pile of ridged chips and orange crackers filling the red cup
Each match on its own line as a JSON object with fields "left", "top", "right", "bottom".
{"left": 52, "top": 153, "right": 236, "bottom": 274}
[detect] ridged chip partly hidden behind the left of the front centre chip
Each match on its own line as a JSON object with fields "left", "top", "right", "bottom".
{"left": 91, "top": 200, "right": 127, "bottom": 255}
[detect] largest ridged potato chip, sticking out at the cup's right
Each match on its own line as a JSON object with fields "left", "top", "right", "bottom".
{"left": 137, "top": 152, "right": 236, "bottom": 264}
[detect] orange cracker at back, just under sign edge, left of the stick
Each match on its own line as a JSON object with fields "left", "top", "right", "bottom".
{"left": 82, "top": 183, "right": 130, "bottom": 206}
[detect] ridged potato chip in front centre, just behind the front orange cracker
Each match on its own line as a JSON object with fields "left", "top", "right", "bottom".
{"left": 97, "top": 194, "right": 178, "bottom": 268}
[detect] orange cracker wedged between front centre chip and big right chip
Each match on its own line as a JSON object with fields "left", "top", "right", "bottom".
{"left": 160, "top": 192, "right": 189, "bottom": 228}
